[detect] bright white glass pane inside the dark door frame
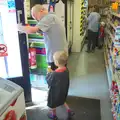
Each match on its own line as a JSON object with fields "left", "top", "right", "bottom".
{"left": 0, "top": 2, "right": 23, "bottom": 78}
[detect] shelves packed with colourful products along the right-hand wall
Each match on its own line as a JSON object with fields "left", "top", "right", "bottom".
{"left": 104, "top": 3, "right": 120, "bottom": 120}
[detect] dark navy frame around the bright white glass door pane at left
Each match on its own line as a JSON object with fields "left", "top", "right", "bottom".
{"left": 8, "top": 0, "right": 32, "bottom": 102}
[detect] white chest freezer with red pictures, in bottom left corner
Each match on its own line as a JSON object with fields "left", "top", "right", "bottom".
{"left": 0, "top": 78, "right": 27, "bottom": 120}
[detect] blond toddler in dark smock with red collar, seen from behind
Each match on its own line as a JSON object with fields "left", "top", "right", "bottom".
{"left": 46, "top": 51, "right": 74, "bottom": 120}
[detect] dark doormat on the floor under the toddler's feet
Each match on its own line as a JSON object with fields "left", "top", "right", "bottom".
{"left": 27, "top": 96, "right": 101, "bottom": 120}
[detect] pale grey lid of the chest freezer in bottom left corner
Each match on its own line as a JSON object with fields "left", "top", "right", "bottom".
{"left": 0, "top": 78, "right": 23, "bottom": 115}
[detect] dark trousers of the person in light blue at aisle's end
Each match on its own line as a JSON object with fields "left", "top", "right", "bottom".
{"left": 87, "top": 30, "right": 98, "bottom": 51}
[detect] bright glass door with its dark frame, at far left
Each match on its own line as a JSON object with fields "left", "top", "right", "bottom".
{"left": 0, "top": 0, "right": 31, "bottom": 101}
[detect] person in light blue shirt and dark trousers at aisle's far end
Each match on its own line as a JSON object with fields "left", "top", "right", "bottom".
{"left": 87, "top": 6, "right": 100, "bottom": 52}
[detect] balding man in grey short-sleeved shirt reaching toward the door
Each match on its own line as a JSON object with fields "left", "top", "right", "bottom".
{"left": 18, "top": 4, "right": 68, "bottom": 70}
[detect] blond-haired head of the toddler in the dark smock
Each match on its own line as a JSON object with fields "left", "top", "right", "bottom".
{"left": 53, "top": 51, "right": 68, "bottom": 65}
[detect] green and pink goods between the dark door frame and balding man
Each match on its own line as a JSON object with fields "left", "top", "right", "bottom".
{"left": 28, "top": 19, "right": 47, "bottom": 74}
